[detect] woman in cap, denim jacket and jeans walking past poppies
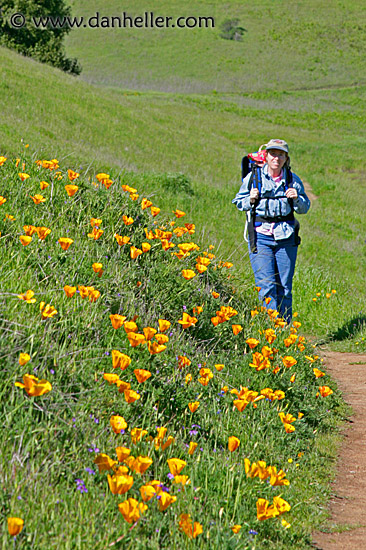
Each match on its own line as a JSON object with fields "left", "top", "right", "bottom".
{"left": 232, "top": 139, "right": 310, "bottom": 323}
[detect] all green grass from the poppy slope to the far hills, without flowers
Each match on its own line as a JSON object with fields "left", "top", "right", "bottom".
{"left": 0, "top": 1, "right": 366, "bottom": 550}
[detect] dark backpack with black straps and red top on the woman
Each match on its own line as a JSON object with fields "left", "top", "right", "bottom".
{"left": 241, "top": 151, "right": 301, "bottom": 254}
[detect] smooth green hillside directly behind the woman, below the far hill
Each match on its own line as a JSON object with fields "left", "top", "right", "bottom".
{"left": 0, "top": 49, "right": 366, "bottom": 350}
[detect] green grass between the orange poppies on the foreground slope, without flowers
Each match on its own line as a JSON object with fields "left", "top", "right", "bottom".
{"left": 0, "top": 153, "right": 344, "bottom": 550}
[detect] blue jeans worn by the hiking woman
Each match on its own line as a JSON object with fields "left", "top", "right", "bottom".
{"left": 249, "top": 233, "right": 297, "bottom": 323}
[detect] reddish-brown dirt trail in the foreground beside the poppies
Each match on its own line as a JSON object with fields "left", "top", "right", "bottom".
{"left": 313, "top": 351, "right": 366, "bottom": 550}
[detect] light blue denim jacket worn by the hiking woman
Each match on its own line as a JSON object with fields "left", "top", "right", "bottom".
{"left": 232, "top": 164, "right": 310, "bottom": 241}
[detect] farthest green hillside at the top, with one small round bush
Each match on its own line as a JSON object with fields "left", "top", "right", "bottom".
{"left": 67, "top": 0, "right": 366, "bottom": 93}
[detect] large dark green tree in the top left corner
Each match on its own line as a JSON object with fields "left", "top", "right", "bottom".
{"left": 0, "top": 0, "right": 81, "bottom": 74}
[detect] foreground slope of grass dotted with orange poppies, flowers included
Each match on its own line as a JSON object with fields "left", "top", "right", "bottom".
{"left": 0, "top": 152, "right": 341, "bottom": 550}
